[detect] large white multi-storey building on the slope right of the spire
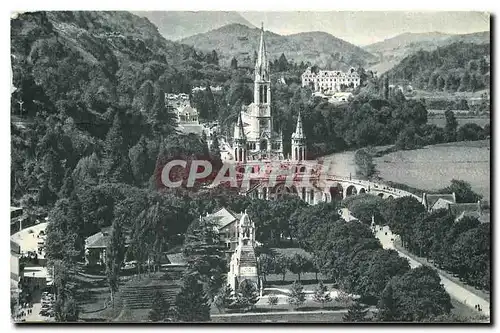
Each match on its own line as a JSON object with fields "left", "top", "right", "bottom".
{"left": 302, "top": 67, "right": 360, "bottom": 92}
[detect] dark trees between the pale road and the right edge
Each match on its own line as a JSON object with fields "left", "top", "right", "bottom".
{"left": 343, "top": 185, "right": 491, "bottom": 290}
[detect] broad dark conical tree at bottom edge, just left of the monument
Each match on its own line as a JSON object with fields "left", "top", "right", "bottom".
{"left": 175, "top": 274, "right": 210, "bottom": 322}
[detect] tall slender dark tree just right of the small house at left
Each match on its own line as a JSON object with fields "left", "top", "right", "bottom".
{"left": 106, "top": 215, "right": 125, "bottom": 307}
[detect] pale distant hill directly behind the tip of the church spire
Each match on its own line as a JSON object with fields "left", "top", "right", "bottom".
{"left": 180, "top": 24, "right": 375, "bottom": 69}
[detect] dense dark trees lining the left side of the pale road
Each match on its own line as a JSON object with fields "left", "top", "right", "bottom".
{"left": 290, "top": 199, "right": 458, "bottom": 321}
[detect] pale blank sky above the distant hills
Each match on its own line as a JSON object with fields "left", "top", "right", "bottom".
{"left": 240, "top": 11, "right": 490, "bottom": 45}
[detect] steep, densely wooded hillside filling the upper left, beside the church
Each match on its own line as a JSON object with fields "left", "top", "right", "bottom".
{"left": 11, "top": 11, "right": 219, "bottom": 207}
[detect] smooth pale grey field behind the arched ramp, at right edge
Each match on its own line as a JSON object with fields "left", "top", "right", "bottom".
{"left": 374, "top": 140, "right": 491, "bottom": 200}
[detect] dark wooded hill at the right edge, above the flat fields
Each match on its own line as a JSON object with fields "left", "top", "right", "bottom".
{"left": 386, "top": 42, "right": 490, "bottom": 92}
